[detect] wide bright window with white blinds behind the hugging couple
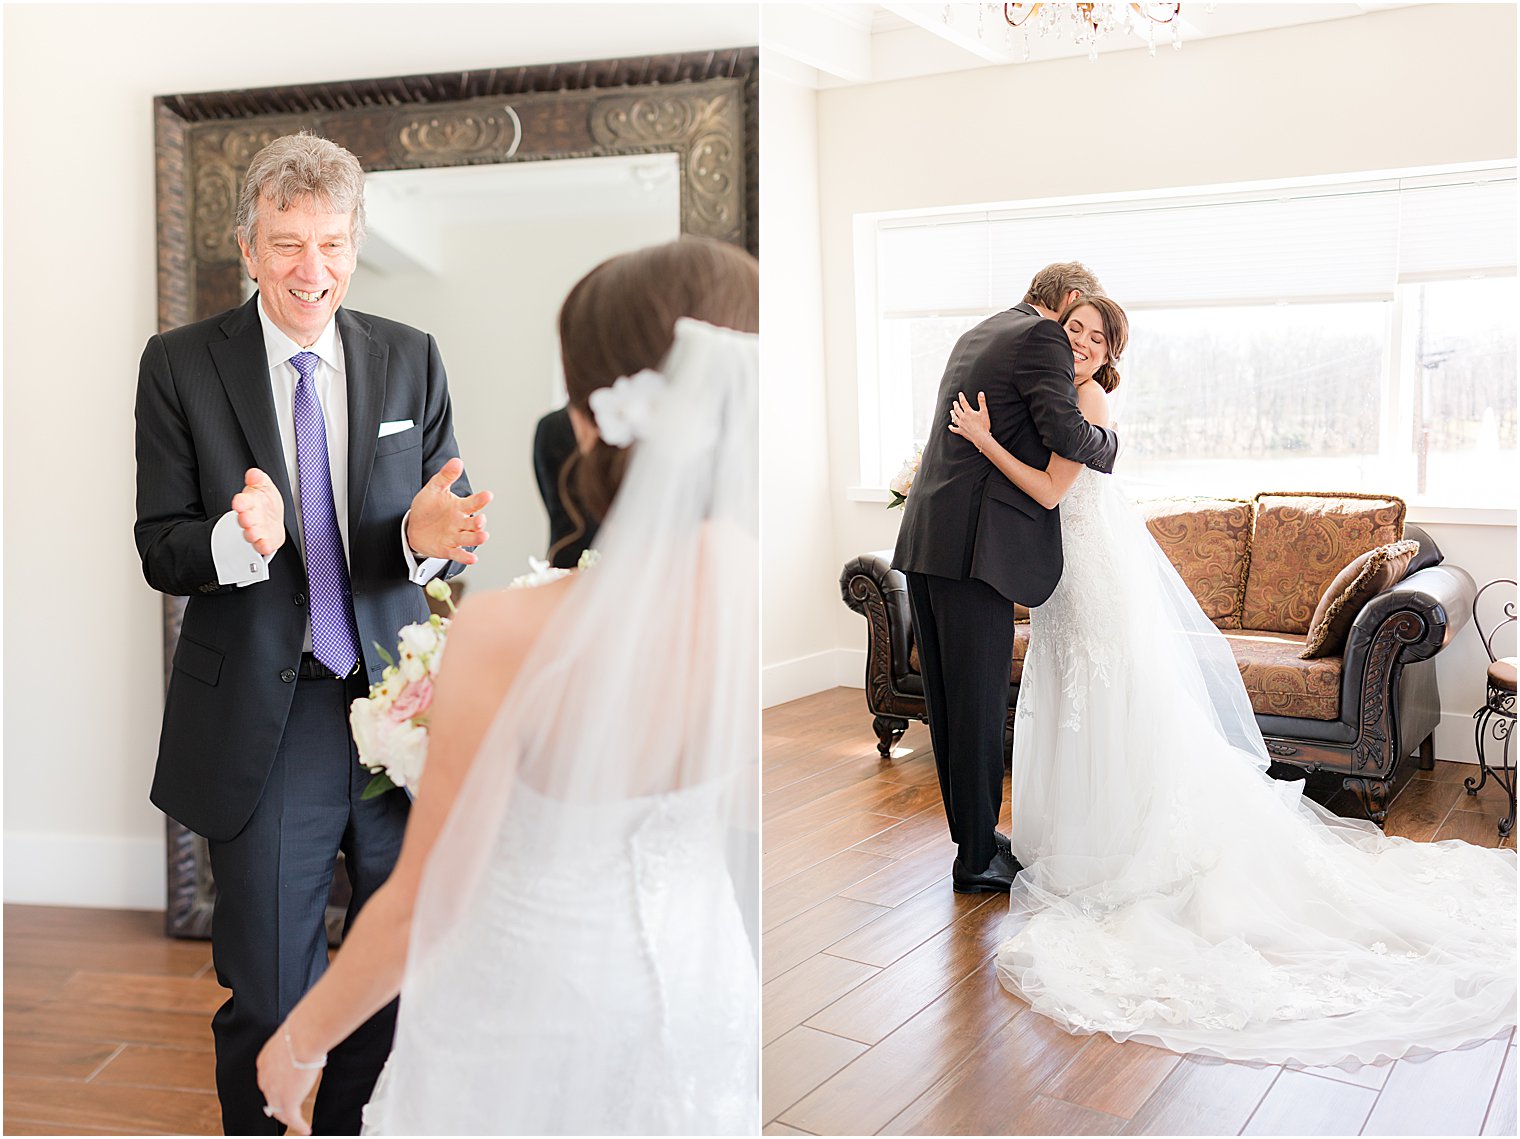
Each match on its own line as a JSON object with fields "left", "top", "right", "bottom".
{"left": 856, "top": 164, "right": 1520, "bottom": 506}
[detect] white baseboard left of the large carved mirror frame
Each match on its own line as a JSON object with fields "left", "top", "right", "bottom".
{"left": 5, "top": 833, "right": 167, "bottom": 909}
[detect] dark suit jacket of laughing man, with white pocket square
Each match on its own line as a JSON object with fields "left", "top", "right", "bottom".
{"left": 135, "top": 297, "right": 470, "bottom": 841}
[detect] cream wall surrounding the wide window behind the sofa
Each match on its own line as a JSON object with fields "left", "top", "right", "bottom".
{"left": 796, "top": 5, "right": 1515, "bottom": 759}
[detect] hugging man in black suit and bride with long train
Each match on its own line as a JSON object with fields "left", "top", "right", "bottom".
{"left": 892, "top": 262, "right": 1515, "bottom": 1064}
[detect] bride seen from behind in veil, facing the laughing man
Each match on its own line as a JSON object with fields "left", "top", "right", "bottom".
{"left": 258, "top": 239, "right": 758, "bottom": 1134}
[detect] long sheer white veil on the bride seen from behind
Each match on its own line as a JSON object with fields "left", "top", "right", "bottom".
{"left": 377, "top": 319, "right": 760, "bottom": 1133}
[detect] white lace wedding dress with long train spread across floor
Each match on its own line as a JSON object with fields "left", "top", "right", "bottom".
{"left": 997, "top": 470, "right": 1515, "bottom": 1064}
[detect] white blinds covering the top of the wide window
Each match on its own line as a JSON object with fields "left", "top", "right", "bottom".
{"left": 877, "top": 169, "right": 1517, "bottom": 316}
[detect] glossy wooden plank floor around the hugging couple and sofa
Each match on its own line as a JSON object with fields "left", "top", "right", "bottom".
{"left": 762, "top": 689, "right": 1515, "bottom": 1134}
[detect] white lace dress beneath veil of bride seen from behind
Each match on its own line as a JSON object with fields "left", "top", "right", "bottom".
{"left": 365, "top": 785, "right": 758, "bottom": 1134}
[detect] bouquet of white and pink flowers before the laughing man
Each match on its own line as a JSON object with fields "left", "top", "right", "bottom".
{"left": 348, "top": 549, "right": 599, "bottom": 798}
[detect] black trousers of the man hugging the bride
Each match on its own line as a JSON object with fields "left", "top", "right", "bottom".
{"left": 906, "top": 573, "right": 1014, "bottom": 873}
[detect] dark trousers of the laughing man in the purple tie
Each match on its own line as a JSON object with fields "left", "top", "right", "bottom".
{"left": 210, "top": 678, "right": 410, "bottom": 1134}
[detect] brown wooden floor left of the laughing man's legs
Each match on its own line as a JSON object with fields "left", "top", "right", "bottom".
{"left": 5, "top": 905, "right": 310, "bottom": 1134}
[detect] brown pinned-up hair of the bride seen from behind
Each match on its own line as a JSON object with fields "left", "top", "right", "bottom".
{"left": 556, "top": 237, "right": 760, "bottom": 549}
